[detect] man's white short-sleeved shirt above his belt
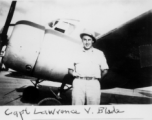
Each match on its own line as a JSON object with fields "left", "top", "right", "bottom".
{"left": 71, "top": 48, "right": 109, "bottom": 78}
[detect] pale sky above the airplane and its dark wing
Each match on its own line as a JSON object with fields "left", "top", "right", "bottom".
{"left": 0, "top": 0, "right": 152, "bottom": 35}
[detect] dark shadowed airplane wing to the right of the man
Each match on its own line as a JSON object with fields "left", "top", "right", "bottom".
{"left": 94, "top": 10, "right": 152, "bottom": 88}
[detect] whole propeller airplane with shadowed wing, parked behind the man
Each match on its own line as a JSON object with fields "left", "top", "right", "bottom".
{"left": 0, "top": 1, "right": 152, "bottom": 104}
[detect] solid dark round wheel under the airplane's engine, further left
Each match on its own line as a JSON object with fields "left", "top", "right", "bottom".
{"left": 22, "top": 86, "right": 39, "bottom": 103}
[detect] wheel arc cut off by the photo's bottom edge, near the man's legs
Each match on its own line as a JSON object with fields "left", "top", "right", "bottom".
{"left": 38, "top": 98, "right": 61, "bottom": 106}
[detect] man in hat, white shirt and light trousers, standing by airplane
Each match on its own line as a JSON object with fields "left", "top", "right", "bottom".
{"left": 69, "top": 30, "right": 108, "bottom": 105}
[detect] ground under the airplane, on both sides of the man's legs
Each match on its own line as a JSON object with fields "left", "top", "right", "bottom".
{"left": 0, "top": 70, "right": 152, "bottom": 106}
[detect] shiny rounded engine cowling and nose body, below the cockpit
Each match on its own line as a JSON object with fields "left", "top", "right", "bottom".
{"left": 4, "top": 21, "right": 80, "bottom": 81}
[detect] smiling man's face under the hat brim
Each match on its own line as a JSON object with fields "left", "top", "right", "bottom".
{"left": 82, "top": 35, "right": 94, "bottom": 50}
